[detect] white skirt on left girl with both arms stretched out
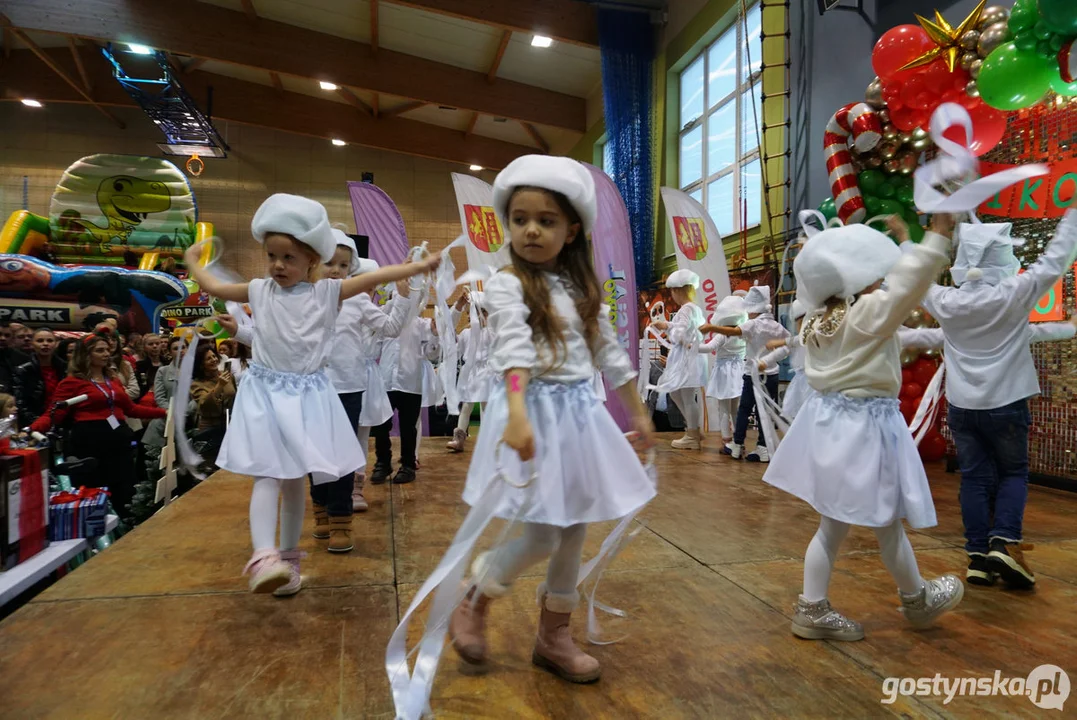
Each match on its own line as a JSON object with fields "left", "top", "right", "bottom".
{"left": 216, "top": 363, "right": 366, "bottom": 484}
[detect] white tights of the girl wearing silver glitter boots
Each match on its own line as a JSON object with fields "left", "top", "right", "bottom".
{"left": 805, "top": 518, "right": 924, "bottom": 603}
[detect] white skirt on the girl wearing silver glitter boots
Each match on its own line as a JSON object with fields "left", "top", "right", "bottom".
{"left": 763, "top": 393, "right": 937, "bottom": 527}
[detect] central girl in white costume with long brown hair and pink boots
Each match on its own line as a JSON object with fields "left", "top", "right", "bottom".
{"left": 432, "top": 155, "right": 655, "bottom": 688}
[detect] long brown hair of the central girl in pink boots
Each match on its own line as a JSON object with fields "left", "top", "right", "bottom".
{"left": 508, "top": 186, "right": 602, "bottom": 370}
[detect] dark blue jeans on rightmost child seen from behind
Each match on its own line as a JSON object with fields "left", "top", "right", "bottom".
{"left": 948, "top": 400, "right": 1032, "bottom": 553}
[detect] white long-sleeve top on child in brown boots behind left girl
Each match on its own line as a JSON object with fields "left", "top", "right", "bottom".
{"left": 326, "top": 293, "right": 418, "bottom": 393}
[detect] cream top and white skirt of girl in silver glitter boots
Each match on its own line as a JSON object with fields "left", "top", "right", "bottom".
{"left": 764, "top": 232, "right": 950, "bottom": 527}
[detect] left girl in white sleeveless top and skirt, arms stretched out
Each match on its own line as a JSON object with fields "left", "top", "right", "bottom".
{"left": 185, "top": 194, "right": 440, "bottom": 595}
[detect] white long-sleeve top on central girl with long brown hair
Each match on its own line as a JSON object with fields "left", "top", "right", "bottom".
{"left": 485, "top": 270, "right": 637, "bottom": 387}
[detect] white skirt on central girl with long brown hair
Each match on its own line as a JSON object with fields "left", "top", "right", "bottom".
{"left": 463, "top": 379, "right": 656, "bottom": 527}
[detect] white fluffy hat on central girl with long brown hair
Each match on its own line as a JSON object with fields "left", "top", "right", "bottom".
{"left": 493, "top": 155, "right": 598, "bottom": 234}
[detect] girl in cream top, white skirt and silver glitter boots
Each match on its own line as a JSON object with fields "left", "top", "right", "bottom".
{"left": 764, "top": 215, "right": 964, "bottom": 640}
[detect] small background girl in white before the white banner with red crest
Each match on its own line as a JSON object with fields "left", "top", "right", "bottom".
{"left": 654, "top": 270, "right": 707, "bottom": 450}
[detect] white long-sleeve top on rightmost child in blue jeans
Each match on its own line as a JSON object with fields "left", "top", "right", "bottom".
{"left": 924, "top": 210, "right": 1077, "bottom": 410}
